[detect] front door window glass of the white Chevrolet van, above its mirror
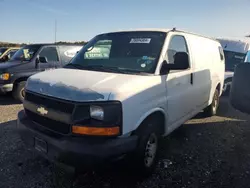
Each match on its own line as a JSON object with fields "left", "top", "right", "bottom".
{"left": 165, "top": 35, "right": 188, "bottom": 64}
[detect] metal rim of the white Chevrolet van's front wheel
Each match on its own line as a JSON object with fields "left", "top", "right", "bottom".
{"left": 144, "top": 133, "right": 158, "bottom": 167}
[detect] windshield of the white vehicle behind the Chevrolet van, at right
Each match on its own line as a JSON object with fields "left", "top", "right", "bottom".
{"left": 224, "top": 50, "right": 246, "bottom": 71}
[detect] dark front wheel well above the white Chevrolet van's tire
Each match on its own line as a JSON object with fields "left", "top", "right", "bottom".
{"left": 135, "top": 111, "right": 166, "bottom": 135}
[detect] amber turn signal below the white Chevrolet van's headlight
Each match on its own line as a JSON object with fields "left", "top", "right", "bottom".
{"left": 72, "top": 125, "right": 120, "bottom": 136}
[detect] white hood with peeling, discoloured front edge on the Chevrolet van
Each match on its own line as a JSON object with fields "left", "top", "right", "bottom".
{"left": 26, "top": 68, "right": 153, "bottom": 102}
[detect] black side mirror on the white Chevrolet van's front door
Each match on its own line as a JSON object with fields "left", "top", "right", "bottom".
{"left": 160, "top": 52, "right": 189, "bottom": 75}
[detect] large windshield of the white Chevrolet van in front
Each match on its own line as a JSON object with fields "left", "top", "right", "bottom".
{"left": 69, "top": 32, "right": 166, "bottom": 73}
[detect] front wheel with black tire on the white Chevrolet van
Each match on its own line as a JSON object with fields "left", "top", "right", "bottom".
{"left": 131, "top": 118, "right": 160, "bottom": 177}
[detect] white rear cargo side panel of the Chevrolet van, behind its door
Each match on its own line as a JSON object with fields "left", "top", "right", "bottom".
{"left": 186, "top": 34, "right": 225, "bottom": 107}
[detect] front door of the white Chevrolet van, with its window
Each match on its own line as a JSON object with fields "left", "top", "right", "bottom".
{"left": 165, "top": 33, "right": 195, "bottom": 128}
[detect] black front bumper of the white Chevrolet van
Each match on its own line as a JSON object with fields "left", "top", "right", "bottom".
{"left": 17, "top": 111, "right": 137, "bottom": 167}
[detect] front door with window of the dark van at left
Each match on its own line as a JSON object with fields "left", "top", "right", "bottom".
{"left": 39, "top": 46, "right": 60, "bottom": 70}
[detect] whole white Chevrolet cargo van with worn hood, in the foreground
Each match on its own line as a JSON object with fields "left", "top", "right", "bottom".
{"left": 17, "top": 29, "right": 225, "bottom": 174}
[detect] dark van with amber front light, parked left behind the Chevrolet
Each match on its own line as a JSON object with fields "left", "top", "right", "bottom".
{"left": 0, "top": 44, "right": 82, "bottom": 101}
